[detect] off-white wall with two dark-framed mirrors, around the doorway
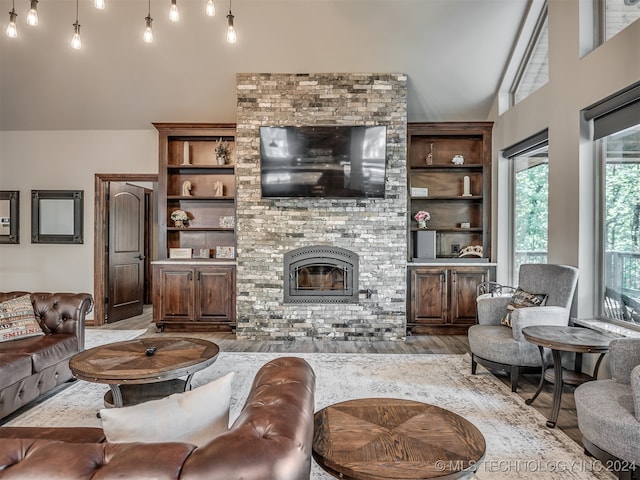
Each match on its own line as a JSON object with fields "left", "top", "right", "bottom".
{"left": 0, "top": 128, "right": 158, "bottom": 302}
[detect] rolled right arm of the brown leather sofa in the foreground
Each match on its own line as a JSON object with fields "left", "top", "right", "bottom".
{"left": 180, "top": 357, "right": 315, "bottom": 480}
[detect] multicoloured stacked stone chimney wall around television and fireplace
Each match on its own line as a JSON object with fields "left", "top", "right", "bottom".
{"left": 236, "top": 73, "right": 407, "bottom": 340}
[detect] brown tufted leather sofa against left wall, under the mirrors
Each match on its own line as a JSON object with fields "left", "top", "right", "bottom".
{"left": 0, "top": 292, "right": 93, "bottom": 419}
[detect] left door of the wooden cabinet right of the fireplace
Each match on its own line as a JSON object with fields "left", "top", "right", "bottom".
{"left": 410, "top": 268, "right": 449, "bottom": 324}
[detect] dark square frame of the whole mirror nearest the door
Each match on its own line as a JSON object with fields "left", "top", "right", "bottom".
{"left": 31, "top": 190, "right": 84, "bottom": 243}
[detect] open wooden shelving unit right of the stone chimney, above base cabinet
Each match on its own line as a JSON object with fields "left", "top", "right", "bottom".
{"left": 407, "top": 122, "right": 492, "bottom": 260}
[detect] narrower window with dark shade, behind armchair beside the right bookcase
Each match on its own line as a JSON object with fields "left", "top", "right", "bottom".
{"left": 503, "top": 130, "right": 549, "bottom": 285}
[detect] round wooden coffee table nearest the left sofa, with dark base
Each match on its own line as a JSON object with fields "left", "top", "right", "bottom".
{"left": 69, "top": 337, "right": 220, "bottom": 407}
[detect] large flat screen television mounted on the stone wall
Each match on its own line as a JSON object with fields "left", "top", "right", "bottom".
{"left": 260, "top": 126, "right": 387, "bottom": 198}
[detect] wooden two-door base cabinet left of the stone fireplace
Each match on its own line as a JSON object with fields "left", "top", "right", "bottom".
{"left": 153, "top": 262, "right": 235, "bottom": 331}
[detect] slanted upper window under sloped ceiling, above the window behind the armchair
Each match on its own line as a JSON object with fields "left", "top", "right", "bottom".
{"left": 511, "top": 8, "right": 549, "bottom": 105}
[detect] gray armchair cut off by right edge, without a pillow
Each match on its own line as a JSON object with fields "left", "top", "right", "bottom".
{"left": 574, "top": 338, "right": 640, "bottom": 478}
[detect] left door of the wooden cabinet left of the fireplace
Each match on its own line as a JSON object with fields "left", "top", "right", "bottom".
{"left": 153, "top": 267, "right": 195, "bottom": 321}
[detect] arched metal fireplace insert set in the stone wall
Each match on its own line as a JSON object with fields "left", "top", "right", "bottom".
{"left": 284, "top": 245, "right": 359, "bottom": 303}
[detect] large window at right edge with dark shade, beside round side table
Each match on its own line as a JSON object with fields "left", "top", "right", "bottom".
{"left": 584, "top": 83, "right": 640, "bottom": 329}
